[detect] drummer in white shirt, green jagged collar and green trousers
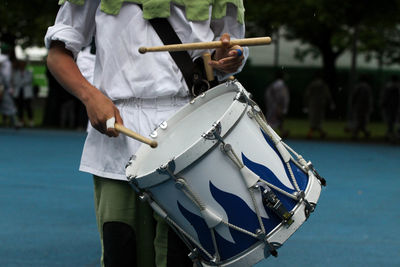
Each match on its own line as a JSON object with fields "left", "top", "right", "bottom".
{"left": 45, "top": 0, "right": 248, "bottom": 267}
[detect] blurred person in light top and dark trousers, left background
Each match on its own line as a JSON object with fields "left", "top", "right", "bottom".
{"left": 12, "top": 60, "right": 34, "bottom": 127}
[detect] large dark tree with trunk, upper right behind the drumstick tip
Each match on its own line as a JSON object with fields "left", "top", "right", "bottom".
{"left": 246, "top": 0, "right": 398, "bottom": 88}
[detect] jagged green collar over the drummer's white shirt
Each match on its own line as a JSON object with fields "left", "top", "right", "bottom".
{"left": 59, "top": 0, "right": 244, "bottom": 24}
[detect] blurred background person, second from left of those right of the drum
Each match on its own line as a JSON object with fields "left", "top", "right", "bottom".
{"left": 303, "top": 74, "right": 335, "bottom": 138}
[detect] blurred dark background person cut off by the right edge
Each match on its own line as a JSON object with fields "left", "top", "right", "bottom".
{"left": 379, "top": 75, "right": 400, "bottom": 141}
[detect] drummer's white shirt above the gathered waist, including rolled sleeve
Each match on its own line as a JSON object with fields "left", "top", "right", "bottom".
{"left": 45, "top": 0, "right": 247, "bottom": 100}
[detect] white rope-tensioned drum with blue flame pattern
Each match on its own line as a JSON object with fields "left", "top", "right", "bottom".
{"left": 126, "top": 81, "right": 325, "bottom": 267}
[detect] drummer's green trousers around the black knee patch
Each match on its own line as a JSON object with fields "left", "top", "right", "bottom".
{"left": 93, "top": 176, "right": 168, "bottom": 267}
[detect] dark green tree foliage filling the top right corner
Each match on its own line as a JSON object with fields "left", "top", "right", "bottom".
{"left": 245, "top": 0, "right": 400, "bottom": 88}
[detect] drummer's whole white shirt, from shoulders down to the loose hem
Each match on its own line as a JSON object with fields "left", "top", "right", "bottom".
{"left": 45, "top": 0, "right": 248, "bottom": 180}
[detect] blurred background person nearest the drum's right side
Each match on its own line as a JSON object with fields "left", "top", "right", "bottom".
{"left": 264, "top": 71, "right": 290, "bottom": 138}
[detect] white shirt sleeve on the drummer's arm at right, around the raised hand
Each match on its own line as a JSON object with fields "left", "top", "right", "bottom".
{"left": 211, "top": 4, "right": 249, "bottom": 81}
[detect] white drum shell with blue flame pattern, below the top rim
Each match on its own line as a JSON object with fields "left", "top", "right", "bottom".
{"left": 126, "top": 82, "right": 321, "bottom": 266}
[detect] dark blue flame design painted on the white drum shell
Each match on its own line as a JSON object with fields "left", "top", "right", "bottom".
{"left": 177, "top": 129, "right": 308, "bottom": 261}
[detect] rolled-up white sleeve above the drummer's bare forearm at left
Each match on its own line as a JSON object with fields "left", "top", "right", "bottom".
{"left": 44, "top": 0, "right": 100, "bottom": 58}
